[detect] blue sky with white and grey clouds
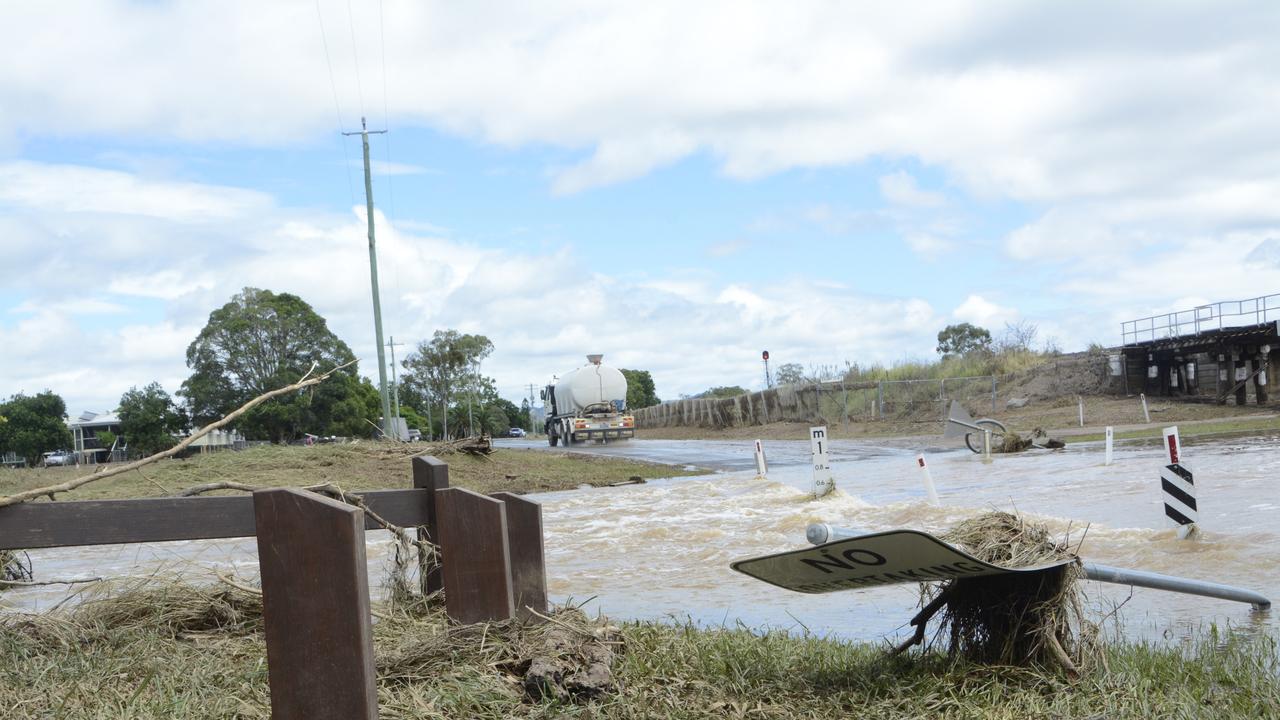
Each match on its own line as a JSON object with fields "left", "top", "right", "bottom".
{"left": 0, "top": 0, "right": 1280, "bottom": 416}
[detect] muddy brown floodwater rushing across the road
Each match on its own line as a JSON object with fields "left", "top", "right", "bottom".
{"left": 4, "top": 436, "right": 1280, "bottom": 639}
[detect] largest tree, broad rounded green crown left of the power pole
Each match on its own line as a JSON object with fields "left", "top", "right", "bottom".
{"left": 180, "top": 287, "right": 379, "bottom": 442}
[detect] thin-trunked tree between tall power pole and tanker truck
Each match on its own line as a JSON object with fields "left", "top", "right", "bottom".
{"left": 401, "top": 329, "right": 497, "bottom": 437}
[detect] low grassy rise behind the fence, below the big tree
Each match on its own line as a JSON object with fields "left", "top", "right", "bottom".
{"left": 0, "top": 441, "right": 698, "bottom": 500}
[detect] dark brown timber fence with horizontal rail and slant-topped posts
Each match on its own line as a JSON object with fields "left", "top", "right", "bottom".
{"left": 0, "top": 456, "right": 547, "bottom": 720}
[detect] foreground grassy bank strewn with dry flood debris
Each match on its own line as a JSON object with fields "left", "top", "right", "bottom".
{"left": 0, "top": 573, "right": 1280, "bottom": 720}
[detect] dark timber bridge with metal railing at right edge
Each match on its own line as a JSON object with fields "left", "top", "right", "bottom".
{"left": 1120, "top": 293, "right": 1280, "bottom": 405}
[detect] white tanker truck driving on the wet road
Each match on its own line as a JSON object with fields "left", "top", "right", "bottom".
{"left": 543, "top": 355, "right": 636, "bottom": 447}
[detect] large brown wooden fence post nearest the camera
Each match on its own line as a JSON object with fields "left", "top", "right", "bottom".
{"left": 253, "top": 488, "right": 378, "bottom": 720}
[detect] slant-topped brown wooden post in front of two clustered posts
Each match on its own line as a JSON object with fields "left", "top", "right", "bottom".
{"left": 435, "top": 488, "right": 516, "bottom": 623}
